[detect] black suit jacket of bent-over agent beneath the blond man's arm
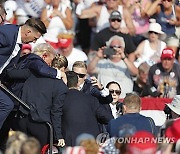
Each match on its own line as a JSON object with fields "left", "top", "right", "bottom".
{"left": 22, "top": 74, "right": 68, "bottom": 139}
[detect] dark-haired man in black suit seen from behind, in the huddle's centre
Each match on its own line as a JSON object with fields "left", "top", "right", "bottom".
{"left": 62, "top": 71, "right": 113, "bottom": 146}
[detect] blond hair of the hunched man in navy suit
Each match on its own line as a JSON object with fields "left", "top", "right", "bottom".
{"left": 33, "top": 43, "right": 55, "bottom": 57}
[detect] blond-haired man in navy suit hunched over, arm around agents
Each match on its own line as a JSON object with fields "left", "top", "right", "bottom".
{"left": 7, "top": 43, "right": 65, "bottom": 97}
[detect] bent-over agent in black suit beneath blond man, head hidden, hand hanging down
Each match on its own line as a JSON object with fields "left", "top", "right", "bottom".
{"left": 9, "top": 69, "right": 68, "bottom": 146}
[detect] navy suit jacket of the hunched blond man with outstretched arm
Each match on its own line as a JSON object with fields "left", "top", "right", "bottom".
{"left": 7, "top": 53, "right": 57, "bottom": 97}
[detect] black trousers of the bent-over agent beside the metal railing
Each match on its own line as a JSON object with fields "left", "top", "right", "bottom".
{"left": 18, "top": 116, "right": 50, "bottom": 147}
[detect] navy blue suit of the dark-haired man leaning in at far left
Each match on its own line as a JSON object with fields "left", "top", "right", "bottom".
{"left": 0, "top": 25, "right": 21, "bottom": 128}
